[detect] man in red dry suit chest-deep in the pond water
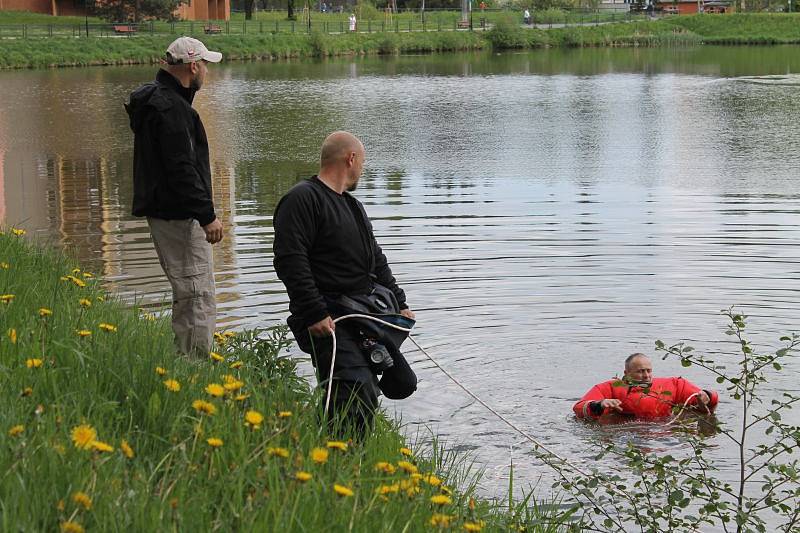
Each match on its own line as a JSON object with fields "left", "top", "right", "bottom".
{"left": 572, "top": 353, "right": 719, "bottom": 418}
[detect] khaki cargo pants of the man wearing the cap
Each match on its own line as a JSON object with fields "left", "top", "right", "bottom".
{"left": 147, "top": 217, "right": 217, "bottom": 358}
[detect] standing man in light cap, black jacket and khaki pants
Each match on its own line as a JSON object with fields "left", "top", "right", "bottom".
{"left": 125, "top": 37, "right": 222, "bottom": 357}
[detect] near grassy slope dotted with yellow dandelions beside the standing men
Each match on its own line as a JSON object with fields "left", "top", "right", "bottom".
{"left": 0, "top": 230, "right": 566, "bottom": 532}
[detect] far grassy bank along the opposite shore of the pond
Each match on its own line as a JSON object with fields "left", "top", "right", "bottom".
{"left": 0, "top": 14, "right": 800, "bottom": 68}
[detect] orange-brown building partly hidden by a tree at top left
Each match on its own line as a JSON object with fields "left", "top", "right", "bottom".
{"left": 0, "top": 0, "right": 231, "bottom": 20}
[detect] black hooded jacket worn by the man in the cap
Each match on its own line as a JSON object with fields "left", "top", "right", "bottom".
{"left": 125, "top": 70, "right": 216, "bottom": 226}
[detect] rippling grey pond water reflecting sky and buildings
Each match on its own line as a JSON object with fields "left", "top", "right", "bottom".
{"left": 0, "top": 47, "right": 800, "bottom": 493}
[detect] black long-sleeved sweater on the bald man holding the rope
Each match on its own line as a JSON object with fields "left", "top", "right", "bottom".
{"left": 272, "top": 176, "right": 407, "bottom": 330}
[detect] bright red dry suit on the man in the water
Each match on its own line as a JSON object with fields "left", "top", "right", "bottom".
{"left": 572, "top": 378, "right": 719, "bottom": 418}
